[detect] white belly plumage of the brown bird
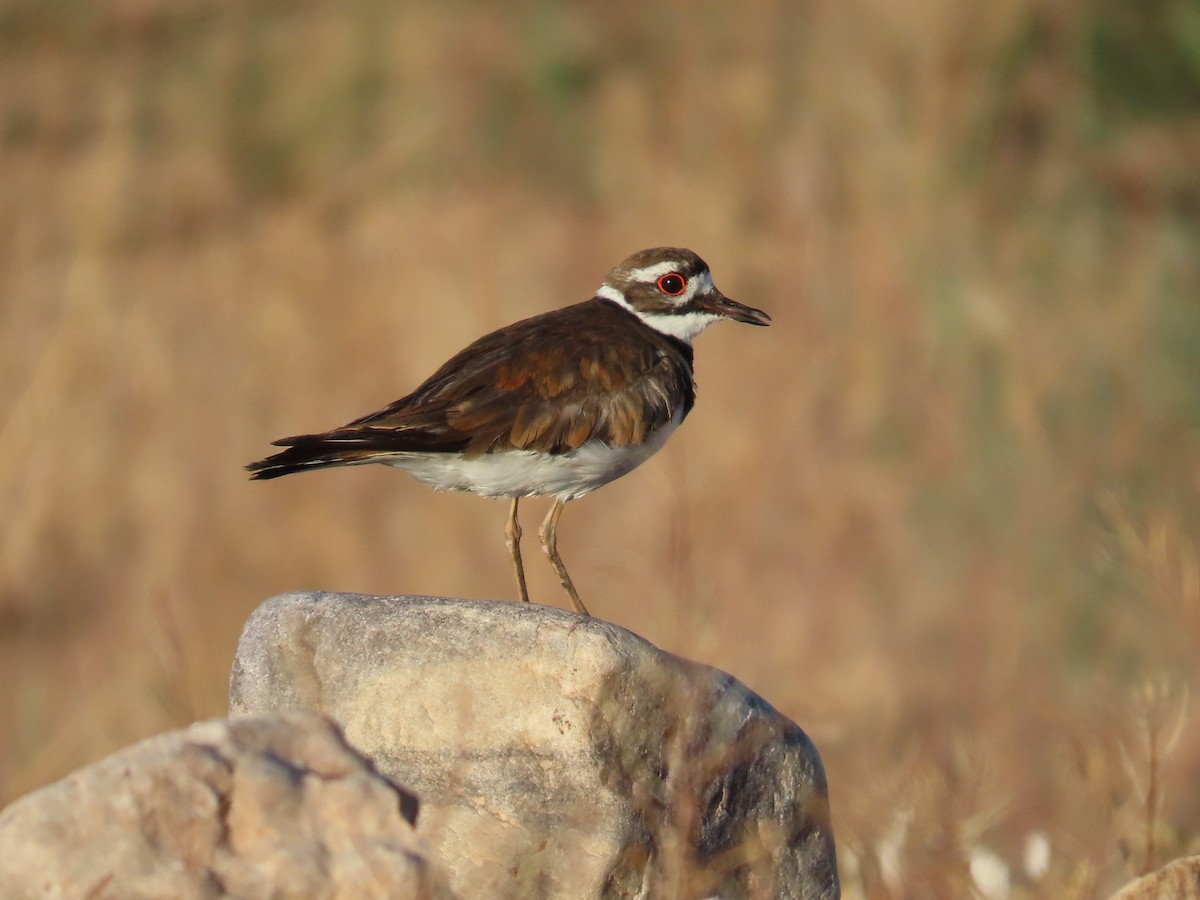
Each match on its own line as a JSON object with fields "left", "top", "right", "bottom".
{"left": 373, "top": 418, "right": 679, "bottom": 500}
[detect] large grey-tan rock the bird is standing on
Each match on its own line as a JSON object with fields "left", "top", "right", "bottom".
{"left": 230, "top": 593, "right": 838, "bottom": 898}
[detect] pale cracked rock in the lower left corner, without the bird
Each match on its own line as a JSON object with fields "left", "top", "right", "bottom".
{"left": 0, "top": 712, "right": 452, "bottom": 900}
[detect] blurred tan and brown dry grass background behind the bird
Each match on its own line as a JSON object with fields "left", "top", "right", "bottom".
{"left": 0, "top": 0, "right": 1200, "bottom": 898}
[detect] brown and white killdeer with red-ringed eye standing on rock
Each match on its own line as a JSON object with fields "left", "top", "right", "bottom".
{"left": 246, "top": 247, "right": 770, "bottom": 614}
